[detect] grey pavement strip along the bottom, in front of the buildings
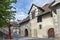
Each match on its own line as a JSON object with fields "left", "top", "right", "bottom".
{"left": 0, "top": 37, "right": 60, "bottom": 40}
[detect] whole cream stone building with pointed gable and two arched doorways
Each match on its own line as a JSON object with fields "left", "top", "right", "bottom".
{"left": 20, "top": 0, "right": 58, "bottom": 38}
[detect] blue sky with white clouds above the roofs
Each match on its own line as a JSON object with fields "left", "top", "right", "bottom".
{"left": 12, "top": 0, "right": 53, "bottom": 20}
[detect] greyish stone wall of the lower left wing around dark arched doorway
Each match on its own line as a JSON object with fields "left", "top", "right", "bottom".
{"left": 20, "top": 22, "right": 30, "bottom": 36}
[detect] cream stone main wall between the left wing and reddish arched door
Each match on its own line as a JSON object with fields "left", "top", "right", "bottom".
{"left": 30, "top": 7, "right": 57, "bottom": 38}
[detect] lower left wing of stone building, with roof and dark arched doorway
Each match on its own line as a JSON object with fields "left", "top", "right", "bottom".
{"left": 20, "top": 16, "right": 30, "bottom": 36}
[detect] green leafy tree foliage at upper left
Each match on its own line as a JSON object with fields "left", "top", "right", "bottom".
{"left": 0, "top": 0, "right": 17, "bottom": 27}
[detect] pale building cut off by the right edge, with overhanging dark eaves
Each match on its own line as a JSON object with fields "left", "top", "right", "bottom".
{"left": 51, "top": 0, "right": 60, "bottom": 38}
